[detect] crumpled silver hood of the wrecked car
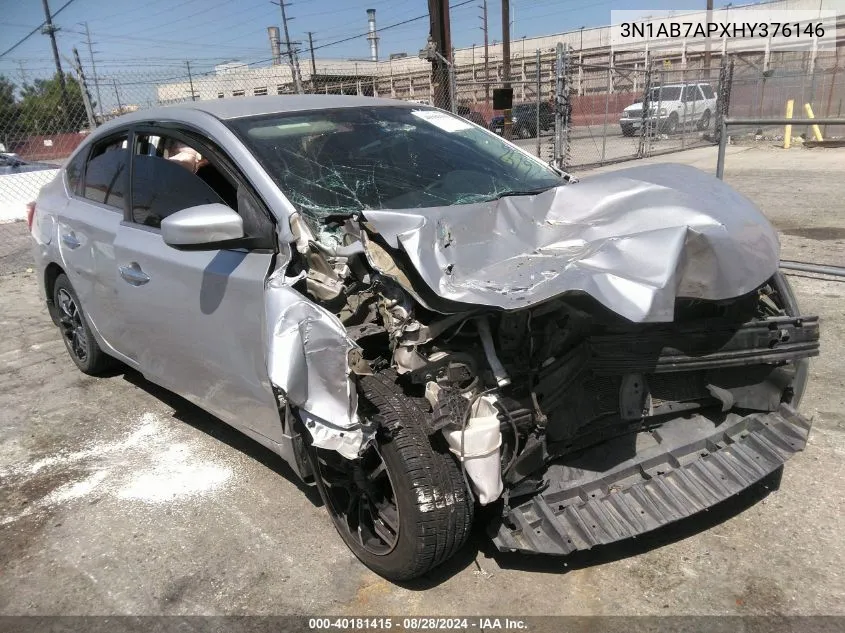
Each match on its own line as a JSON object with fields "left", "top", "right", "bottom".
{"left": 363, "top": 165, "right": 780, "bottom": 322}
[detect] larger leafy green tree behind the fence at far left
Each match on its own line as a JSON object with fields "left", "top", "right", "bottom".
{"left": 19, "top": 73, "right": 88, "bottom": 134}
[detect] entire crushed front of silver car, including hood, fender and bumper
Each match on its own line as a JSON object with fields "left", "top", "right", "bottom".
{"left": 274, "top": 160, "right": 819, "bottom": 554}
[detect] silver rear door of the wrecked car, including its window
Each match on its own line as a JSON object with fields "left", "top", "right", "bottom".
{"left": 57, "top": 131, "right": 129, "bottom": 355}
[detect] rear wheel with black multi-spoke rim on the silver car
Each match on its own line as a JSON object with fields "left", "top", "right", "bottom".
{"left": 53, "top": 273, "right": 115, "bottom": 376}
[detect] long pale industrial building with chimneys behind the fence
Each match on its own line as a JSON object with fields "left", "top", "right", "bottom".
{"left": 157, "top": 0, "right": 845, "bottom": 110}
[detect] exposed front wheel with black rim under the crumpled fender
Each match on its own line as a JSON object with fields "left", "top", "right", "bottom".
{"left": 309, "top": 372, "right": 474, "bottom": 581}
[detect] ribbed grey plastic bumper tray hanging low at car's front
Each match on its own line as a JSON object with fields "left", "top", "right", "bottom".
{"left": 493, "top": 405, "right": 811, "bottom": 555}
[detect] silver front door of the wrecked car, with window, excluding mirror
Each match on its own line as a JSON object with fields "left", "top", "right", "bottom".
{"left": 115, "top": 131, "right": 281, "bottom": 441}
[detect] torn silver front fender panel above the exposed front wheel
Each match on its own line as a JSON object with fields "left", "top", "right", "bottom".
{"left": 264, "top": 271, "right": 374, "bottom": 459}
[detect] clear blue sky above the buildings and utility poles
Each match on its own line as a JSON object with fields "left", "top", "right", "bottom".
{"left": 0, "top": 0, "right": 712, "bottom": 84}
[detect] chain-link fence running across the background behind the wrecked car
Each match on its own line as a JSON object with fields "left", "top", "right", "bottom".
{"left": 0, "top": 42, "right": 845, "bottom": 273}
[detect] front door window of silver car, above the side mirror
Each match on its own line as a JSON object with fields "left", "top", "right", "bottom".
{"left": 127, "top": 134, "right": 231, "bottom": 228}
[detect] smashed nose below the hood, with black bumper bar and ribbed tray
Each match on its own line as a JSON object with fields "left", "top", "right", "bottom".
{"left": 372, "top": 274, "right": 819, "bottom": 554}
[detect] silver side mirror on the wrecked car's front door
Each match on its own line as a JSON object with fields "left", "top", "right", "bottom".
{"left": 161, "top": 202, "right": 244, "bottom": 250}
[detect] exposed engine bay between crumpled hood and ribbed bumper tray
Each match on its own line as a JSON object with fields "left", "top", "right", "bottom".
{"left": 278, "top": 196, "right": 819, "bottom": 524}
